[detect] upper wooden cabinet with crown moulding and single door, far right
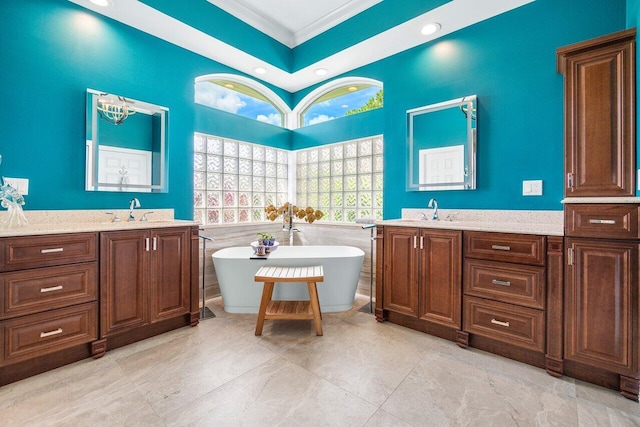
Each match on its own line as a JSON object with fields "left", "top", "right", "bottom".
{"left": 558, "top": 30, "right": 636, "bottom": 197}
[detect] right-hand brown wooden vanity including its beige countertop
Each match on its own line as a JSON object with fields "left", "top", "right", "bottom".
{"left": 376, "top": 212, "right": 563, "bottom": 376}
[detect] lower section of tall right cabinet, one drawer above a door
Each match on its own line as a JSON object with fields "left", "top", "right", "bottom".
{"left": 564, "top": 204, "right": 640, "bottom": 400}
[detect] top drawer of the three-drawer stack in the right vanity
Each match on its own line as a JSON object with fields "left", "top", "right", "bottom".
{"left": 464, "top": 231, "right": 546, "bottom": 266}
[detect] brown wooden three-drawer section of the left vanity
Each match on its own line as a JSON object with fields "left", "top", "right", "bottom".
{"left": 0, "top": 233, "right": 98, "bottom": 385}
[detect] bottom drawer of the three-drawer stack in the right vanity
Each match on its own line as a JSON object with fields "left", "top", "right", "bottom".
{"left": 464, "top": 296, "right": 545, "bottom": 351}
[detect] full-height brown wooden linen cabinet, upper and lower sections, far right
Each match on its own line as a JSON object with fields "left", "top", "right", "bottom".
{"left": 557, "top": 29, "right": 640, "bottom": 400}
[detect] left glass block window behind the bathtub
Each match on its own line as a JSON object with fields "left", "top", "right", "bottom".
{"left": 193, "top": 133, "right": 289, "bottom": 224}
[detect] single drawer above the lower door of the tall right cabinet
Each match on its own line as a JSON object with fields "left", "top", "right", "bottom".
{"left": 564, "top": 204, "right": 640, "bottom": 239}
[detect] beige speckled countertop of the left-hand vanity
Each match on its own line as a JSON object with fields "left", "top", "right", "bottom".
{"left": 0, "top": 209, "right": 199, "bottom": 237}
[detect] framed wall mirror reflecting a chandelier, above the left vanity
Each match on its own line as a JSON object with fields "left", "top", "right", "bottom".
{"left": 86, "top": 89, "right": 169, "bottom": 192}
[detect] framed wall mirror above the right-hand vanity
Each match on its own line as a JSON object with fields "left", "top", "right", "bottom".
{"left": 407, "top": 95, "right": 477, "bottom": 191}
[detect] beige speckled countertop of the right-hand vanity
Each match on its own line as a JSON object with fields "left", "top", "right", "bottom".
{"left": 377, "top": 209, "right": 564, "bottom": 236}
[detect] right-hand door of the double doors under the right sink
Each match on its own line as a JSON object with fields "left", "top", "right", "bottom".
{"left": 418, "top": 230, "right": 462, "bottom": 329}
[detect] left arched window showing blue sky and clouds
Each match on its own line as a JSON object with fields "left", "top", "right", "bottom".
{"left": 195, "top": 74, "right": 291, "bottom": 127}
